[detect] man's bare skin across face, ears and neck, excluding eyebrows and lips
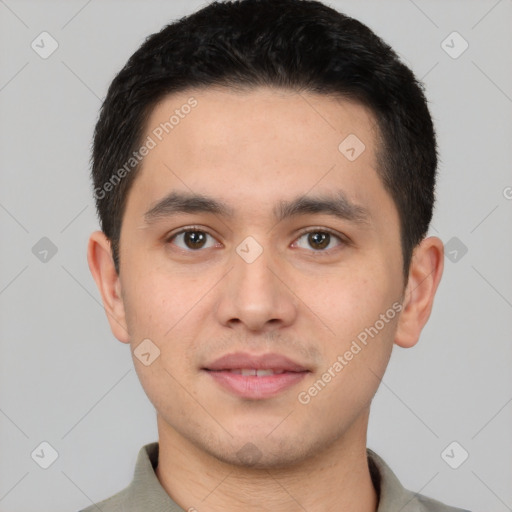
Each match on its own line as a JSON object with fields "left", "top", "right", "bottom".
{"left": 88, "top": 88, "right": 443, "bottom": 512}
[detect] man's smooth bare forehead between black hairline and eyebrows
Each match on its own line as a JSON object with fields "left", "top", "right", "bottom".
{"left": 124, "top": 88, "right": 392, "bottom": 224}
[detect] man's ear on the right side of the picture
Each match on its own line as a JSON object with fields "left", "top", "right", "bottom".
{"left": 395, "top": 236, "right": 444, "bottom": 348}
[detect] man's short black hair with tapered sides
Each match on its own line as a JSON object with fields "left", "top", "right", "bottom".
{"left": 91, "top": 0, "right": 437, "bottom": 280}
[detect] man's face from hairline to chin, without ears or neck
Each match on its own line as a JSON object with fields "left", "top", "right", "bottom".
{"left": 101, "top": 88, "right": 404, "bottom": 467}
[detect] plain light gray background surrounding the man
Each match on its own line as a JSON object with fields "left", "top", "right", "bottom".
{"left": 0, "top": 0, "right": 512, "bottom": 512}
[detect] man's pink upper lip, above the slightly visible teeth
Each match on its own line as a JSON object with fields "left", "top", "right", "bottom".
{"left": 204, "top": 352, "right": 309, "bottom": 372}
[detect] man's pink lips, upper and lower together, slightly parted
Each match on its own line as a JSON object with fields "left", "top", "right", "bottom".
{"left": 202, "top": 352, "right": 310, "bottom": 400}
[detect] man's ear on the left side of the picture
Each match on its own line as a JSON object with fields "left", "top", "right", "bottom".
{"left": 87, "top": 231, "right": 130, "bottom": 343}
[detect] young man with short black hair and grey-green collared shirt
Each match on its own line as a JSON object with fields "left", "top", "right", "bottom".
{"left": 86, "top": 0, "right": 472, "bottom": 512}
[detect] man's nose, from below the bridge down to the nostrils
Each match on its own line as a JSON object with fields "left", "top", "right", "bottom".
{"left": 217, "top": 242, "right": 297, "bottom": 332}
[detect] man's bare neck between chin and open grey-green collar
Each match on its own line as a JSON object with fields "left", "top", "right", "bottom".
{"left": 156, "top": 413, "right": 378, "bottom": 512}
